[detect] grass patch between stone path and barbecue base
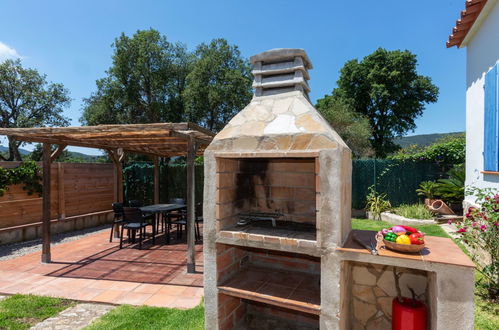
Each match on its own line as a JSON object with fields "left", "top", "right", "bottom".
{"left": 85, "top": 304, "right": 204, "bottom": 330}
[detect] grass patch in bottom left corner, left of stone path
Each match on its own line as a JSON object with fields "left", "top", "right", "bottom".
{"left": 0, "top": 294, "right": 74, "bottom": 330}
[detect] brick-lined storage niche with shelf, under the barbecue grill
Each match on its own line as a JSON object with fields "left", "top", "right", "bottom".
{"left": 217, "top": 244, "right": 320, "bottom": 329}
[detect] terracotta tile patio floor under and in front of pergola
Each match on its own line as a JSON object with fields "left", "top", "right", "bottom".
{"left": 0, "top": 231, "right": 203, "bottom": 308}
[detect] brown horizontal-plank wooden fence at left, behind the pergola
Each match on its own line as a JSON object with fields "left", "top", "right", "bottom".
{"left": 0, "top": 162, "right": 115, "bottom": 229}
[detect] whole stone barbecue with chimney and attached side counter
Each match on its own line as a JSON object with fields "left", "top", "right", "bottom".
{"left": 203, "top": 49, "right": 473, "bottom": 330}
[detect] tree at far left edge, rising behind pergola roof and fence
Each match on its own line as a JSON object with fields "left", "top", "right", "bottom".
{"left": 0, "top": 60, "right": 71, "bottom": 161}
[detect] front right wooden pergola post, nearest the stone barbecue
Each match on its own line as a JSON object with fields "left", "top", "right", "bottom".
{"left": 187, "top": 135, "right": 197, "bottom": 273}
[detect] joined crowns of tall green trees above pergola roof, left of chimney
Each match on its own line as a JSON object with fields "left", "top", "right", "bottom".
{"left": 81, "top": 29, "right": 251, "bottom": 129}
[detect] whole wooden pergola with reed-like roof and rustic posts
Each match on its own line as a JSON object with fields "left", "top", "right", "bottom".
{"left": 0, "top": 123, "right": 215, "bottom": 273}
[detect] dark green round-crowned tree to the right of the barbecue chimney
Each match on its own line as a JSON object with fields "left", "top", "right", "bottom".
{"left": 333, "top": 48, "right": 438, "bottom": 158}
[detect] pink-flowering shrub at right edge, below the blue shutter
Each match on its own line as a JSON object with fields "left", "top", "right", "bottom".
{"left": 457, "top": 188, "right": 499, "bottom": 299}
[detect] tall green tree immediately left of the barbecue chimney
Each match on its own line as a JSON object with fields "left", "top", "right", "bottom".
{"left": 183, "top": 39, "right": 253, "bottom": 131}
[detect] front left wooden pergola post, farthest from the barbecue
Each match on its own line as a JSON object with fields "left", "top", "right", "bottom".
{"left": 42, "top": 143, "right": 52, "bottom": 263}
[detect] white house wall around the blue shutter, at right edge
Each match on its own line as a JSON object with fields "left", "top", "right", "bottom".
{"left": 466, "top": 2, "right": 499, "bottom": 203}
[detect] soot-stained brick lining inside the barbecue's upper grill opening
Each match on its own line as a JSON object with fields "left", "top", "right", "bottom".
{"left": 217, "top": 158, "right": 319, "bottom": 229}
